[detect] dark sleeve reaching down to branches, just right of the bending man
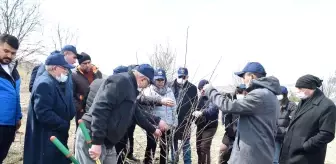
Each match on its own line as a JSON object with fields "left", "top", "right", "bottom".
{"left": 134, "top": 108, "right": 156, "bottom": 134}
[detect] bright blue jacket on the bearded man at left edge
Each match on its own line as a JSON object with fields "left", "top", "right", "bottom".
{"left": 0, "top": 62, "right": 22, "bottom": 126}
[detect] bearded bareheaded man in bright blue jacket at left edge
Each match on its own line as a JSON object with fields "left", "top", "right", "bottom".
{"left": 0, "top": 34, "right": 22, "bottom": 163}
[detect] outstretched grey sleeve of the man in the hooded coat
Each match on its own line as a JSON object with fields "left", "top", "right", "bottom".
{"left": 205, "top": 86, "right": 262, "bottom": 115}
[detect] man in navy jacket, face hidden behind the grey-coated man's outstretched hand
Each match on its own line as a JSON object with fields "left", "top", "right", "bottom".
{"left": 193, "top": 80, "right": 218, "bottom": 164}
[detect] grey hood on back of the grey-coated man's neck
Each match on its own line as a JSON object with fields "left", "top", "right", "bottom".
{"left": 251, "top": 76, "right": 281, "bottom": 95}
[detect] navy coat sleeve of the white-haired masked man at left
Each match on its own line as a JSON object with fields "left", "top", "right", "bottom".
{"left": 32, "top": 83, "right": 70, "bottom": 131}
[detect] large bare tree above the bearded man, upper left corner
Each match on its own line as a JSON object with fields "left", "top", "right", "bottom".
{"left": 0, "top": 0, "right": 44, "bottom": 61}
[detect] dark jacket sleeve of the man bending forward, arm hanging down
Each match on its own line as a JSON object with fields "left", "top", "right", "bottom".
{"left": 91, "top": 77, "right": 127, "bottom": 145}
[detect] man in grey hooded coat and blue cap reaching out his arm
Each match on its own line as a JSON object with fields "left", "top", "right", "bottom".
{"left": 204, "top": 62, "right": 281, "bottom": 164}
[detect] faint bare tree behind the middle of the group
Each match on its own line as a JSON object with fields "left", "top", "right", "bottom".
{"left": 149, "top": 44, "right": 176, "bottom": 81}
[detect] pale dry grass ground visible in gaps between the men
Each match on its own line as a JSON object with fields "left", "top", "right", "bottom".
{"left": 4, "top": 67, "right": 336, "bottom": 164}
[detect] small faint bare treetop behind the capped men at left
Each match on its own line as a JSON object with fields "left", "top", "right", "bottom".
{"left": 52, "top": 24, "right": 78, "bottom": 50}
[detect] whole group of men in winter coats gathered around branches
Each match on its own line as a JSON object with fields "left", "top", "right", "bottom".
{"left": 0, "top": 34, "right": 336, "bottom": 164}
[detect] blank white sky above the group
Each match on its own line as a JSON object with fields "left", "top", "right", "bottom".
{"left": 36, "top": 0, "right": 336, "bottom": 85}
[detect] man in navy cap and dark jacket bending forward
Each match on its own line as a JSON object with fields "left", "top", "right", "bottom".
{"left": 76, "top": 64, "right": 159, "bottom": 163}
